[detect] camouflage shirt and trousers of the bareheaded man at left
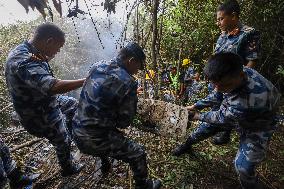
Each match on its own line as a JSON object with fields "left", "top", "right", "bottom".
{"left": 5, "top": 42, "right": 77, "bottom": 167}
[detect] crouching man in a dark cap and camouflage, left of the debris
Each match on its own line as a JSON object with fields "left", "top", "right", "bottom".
{"left": 73, "top": 43, "right": 161, "bottom": 189}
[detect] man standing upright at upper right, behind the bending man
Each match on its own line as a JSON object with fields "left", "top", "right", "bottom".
{"left": 211, "top": 0, "right": 260, "bottom": 145}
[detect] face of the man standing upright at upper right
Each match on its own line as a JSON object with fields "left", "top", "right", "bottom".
{"left": 216, "top": 11, "right": 235, "bottom": 31}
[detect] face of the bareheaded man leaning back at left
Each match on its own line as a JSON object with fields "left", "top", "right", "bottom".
{"left": 44, "top": 38, "right": 65, "bottom": 59}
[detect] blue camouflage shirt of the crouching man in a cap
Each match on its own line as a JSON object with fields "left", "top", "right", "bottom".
{"left": 73, "top": 58, "right": 138, "bottom": 130}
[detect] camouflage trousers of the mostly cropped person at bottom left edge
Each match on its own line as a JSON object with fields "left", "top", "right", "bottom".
{"left": 0, "top": 138, "right": 16, "bottom": 188}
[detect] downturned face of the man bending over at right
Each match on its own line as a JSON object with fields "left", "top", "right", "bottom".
{"left": 210, "top": 72, "right": 244, "bottom": 93}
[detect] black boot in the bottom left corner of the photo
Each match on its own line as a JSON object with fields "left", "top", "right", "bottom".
{"left": 8, "top": 168, "right": 39, "bottom": 189}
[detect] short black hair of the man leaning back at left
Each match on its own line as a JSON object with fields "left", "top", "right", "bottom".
{"left": 34, "top": 23, "right": 65, "bottom": 40}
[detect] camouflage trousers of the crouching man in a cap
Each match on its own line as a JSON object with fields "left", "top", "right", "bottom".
{"left": 73, "top": 128, "right": 148, "bottom": 184}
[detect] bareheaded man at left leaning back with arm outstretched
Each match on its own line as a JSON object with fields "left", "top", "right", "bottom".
{"left": 5, "top": 23, "right": 85, "bottom": 176}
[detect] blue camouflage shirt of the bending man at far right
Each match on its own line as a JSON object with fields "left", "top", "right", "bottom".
{"left": 196, "top": 68, "right": 280, "bottom": 130}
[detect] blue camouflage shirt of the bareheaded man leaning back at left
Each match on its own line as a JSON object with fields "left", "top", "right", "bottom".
{"left": 5, "top": 41, "right": 61, "bottom": 124}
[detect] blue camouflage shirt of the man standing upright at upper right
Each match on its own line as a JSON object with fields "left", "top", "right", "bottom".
{"left": 214, "top": 24, "right": 260, "bottom": 62}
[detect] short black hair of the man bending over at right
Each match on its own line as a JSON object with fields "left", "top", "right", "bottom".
{"left": 203, "top": 52, "right": 243, "bottom": 82}
